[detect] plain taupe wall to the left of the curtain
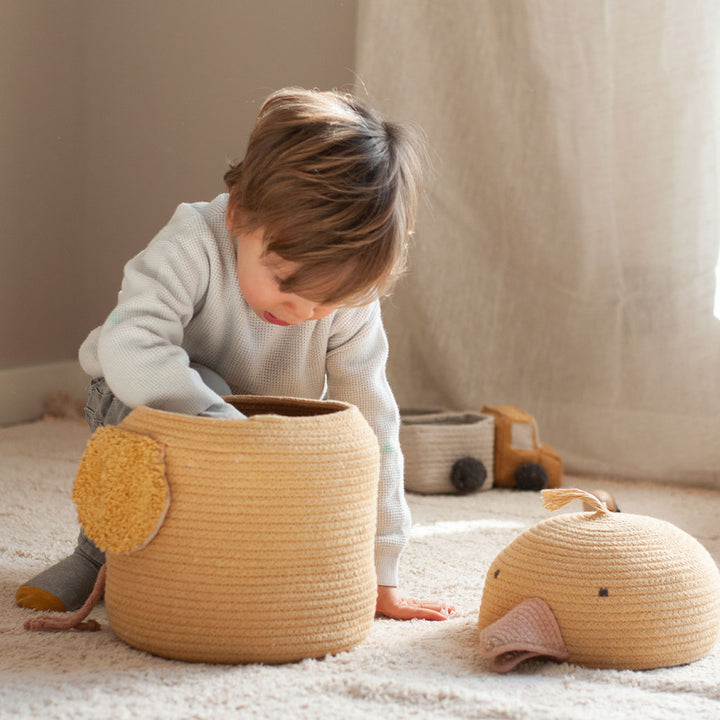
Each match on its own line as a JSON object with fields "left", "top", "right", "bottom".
{"left": 0, "top": 0, "right": 356, "bottom": 370}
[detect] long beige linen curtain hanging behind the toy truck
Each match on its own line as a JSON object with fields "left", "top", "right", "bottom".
{"left": 357, "top": 0, "right": 720, "bottom": 486}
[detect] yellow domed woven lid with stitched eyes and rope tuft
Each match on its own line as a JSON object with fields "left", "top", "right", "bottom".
{"left": 479, "top": 490, "right": 720, "bottom": 670}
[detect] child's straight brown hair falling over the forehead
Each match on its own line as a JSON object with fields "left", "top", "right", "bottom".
{"left": 224, "top": 88, "right": 426, "bottom": 305}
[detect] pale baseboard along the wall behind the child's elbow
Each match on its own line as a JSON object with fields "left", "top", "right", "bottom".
{"left": 0, "top": 360, "right": 90, "bottom": 425}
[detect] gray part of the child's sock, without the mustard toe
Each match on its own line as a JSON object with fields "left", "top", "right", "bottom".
{"left": 25, "top": 530, "right": 105, "bottom": 612}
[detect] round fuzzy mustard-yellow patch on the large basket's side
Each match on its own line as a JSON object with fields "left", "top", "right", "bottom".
{"left": 73, "top": 425, "right": 170, "bottom": 553}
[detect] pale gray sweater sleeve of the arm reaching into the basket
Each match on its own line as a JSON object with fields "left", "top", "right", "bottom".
{"left": 80, "top": 206, "right": 242, "bottom": 417}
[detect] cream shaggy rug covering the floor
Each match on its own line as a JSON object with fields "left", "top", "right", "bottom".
{"left": 0, "top": 420, "right": 720, "bottom": 720}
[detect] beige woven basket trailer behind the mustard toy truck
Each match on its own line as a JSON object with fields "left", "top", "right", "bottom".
{"left": 400, "top": 410, "right": 495, "bottom": 494}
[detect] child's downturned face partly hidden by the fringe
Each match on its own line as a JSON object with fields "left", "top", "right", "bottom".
{"left": 233, "top": 228, "right": 337, "bottom": 326}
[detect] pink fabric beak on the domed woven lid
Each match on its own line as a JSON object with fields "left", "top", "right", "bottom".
{"left": 480, "top": 598, "right": 570, "bottom": 673}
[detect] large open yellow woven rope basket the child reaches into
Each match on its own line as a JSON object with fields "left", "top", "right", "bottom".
{"left": 75, "top": 397, "right": 378, "bottom": 663}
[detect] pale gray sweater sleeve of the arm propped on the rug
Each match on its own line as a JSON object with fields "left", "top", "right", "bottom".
{"left": 327, "top": 302, "right": 410, "bottom": 586}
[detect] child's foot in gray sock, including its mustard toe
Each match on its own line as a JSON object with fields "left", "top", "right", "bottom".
{"left": 15, "top": 532, "right": 105, "bottom": 612}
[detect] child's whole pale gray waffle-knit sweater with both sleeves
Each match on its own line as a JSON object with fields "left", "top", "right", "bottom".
{"left": 80, "top": 194, "right": 410, "bottom": 585}
